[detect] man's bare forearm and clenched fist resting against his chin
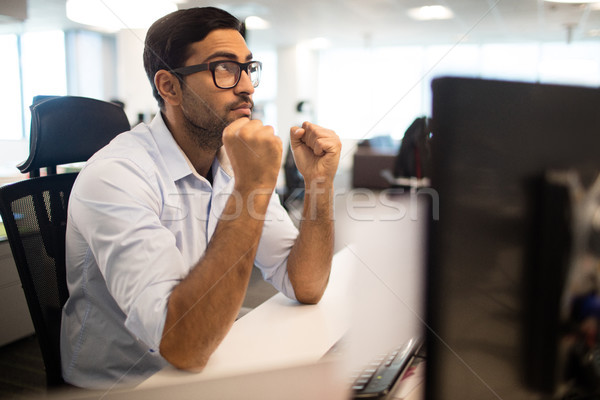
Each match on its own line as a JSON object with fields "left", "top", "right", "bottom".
{"left": 160, "top": 118, "right": 282, "bottom": 369}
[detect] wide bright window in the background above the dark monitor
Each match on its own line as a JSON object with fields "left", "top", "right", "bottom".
{"left": 317, "top": 42, "right": 600, "bottom": 140}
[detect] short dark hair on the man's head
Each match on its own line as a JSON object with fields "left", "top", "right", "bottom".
{"left": 144, "top": 7, "right": 244, "bottom": 109}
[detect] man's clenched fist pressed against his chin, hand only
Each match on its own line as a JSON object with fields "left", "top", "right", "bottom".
{"left": 223, "top": 118, "right": 282, "bottom": 190}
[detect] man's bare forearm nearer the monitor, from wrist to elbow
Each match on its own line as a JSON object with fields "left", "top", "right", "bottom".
{"left": 287, "top": 181, "right": 334, "bottom": 304}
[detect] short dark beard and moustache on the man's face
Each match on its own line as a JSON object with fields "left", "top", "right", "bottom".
{"left": 181, "top": 89, "right": 254, "bottom": 151}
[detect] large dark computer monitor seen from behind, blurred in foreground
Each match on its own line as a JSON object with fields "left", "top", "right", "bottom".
{"left": 426, "top": 78, "right": 600, "bottom": 400}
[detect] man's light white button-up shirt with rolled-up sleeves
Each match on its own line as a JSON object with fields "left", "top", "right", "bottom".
{"left": 61, "top": 113, "right": 298, "bottom": 388}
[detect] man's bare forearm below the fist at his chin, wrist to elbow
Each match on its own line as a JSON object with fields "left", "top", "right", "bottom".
{"left": 160, "top": 191, "right": 270, "bottom": 369}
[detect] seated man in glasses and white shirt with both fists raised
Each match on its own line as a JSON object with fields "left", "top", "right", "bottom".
{"left": 61, "top": 7, "right": 341, "bottom": 388}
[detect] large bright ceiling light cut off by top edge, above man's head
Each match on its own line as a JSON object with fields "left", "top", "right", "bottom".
{"left": 67, "top": 0, "right": 177, "bottom": 31}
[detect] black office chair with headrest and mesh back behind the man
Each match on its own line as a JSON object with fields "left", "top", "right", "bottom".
{"left": 0, "top": 96, "right": 130, "bottom": 386}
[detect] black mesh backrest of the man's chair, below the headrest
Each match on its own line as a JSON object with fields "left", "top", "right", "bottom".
{"left": 0, "top": 173, "right": 77, "bottom": 386}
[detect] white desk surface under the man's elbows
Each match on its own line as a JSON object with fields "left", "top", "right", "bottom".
{"left": 129, "top": 250, "right": 356, "bottom": 399}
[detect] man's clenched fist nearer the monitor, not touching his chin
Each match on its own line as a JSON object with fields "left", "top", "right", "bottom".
{"left": 290, "top": 122, "right": 342, "bottom": 183}
